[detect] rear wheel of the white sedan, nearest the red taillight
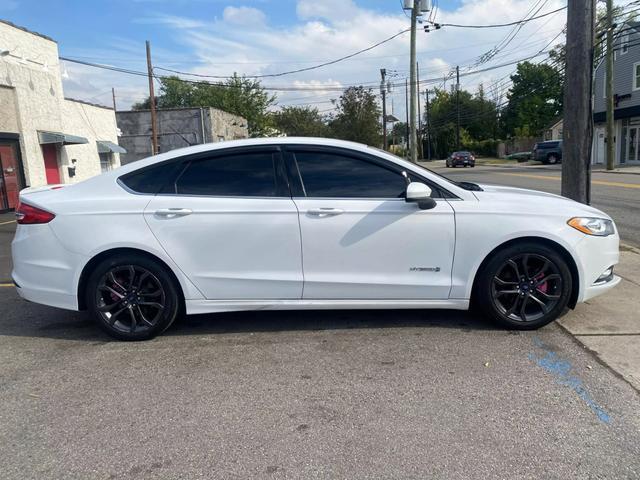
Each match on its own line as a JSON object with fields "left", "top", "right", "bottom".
{"left": 86, "top": 254, "right": 181, "bottom": 341}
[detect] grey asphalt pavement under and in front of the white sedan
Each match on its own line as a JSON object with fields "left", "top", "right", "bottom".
{"left": 0, "top": 212, "right": 640, "bottom": 479}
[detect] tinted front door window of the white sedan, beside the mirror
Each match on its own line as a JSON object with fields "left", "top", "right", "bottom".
{"left": 295, "top": 152, "right": 407, "bottom": 198}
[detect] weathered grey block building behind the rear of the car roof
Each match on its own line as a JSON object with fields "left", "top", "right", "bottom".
{"left": 116, "top": 107, "right": 249, "bottom": 164}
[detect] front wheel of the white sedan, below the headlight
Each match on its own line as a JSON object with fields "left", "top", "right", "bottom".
{"left": 474, "top": 242, "right": 572, "bottom": 330}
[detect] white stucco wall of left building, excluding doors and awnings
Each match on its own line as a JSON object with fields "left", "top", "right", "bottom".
{"left": 0, "top": 21, "right": 119, "bottom": 186}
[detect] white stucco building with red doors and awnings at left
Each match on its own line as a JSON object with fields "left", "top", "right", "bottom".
{"left": 0, "top": 20, "right": 124, "bottom": 211}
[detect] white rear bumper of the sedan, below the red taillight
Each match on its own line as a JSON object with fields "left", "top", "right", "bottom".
{"left": 11, "top": 224, "right": 86, "bottom": 310}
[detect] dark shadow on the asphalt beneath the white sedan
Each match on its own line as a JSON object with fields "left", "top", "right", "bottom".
{"left": 0, "top": 288, "right": 499, "bottom": 342}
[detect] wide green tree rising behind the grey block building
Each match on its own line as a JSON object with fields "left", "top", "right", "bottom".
{"left": 132, "top": 74, "right": 276, "bottom": 137}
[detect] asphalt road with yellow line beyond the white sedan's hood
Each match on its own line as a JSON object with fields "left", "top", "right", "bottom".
{"left": 422, "top": 162, "right": 640, "bottom": 247}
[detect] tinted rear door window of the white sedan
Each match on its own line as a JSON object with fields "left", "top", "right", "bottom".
{"left": 174, "top": 152, "right": 276, "bottom": 197}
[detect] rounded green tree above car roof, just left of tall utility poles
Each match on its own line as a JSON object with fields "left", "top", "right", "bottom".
{"left": 329, "top": 86, "right": 382, "bottom": 147}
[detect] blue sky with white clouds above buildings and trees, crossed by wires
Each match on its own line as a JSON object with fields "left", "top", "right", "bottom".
{"left": 0, "top": 0, "right": 637, "bottom": 118}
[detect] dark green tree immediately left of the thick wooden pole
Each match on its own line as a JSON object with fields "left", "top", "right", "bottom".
{"left": 502, "top": 62, "right": 563, "bottom": 136}
